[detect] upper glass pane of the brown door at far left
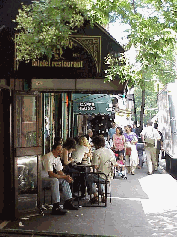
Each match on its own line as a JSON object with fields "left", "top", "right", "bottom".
{"left": 16, "top": 96, "right": 37, "bottom": 147}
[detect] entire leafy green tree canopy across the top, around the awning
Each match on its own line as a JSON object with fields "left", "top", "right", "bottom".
{"left": 15, "top": 0, "right": 177, "bottom": 88}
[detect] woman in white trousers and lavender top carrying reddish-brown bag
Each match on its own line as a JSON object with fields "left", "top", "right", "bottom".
{"left": 124, "top": 125, "right": 139, "bottom": 175}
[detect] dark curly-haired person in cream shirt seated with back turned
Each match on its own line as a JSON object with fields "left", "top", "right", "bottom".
{"left": 87, "top": 136, "right": 117, "bottom": 203}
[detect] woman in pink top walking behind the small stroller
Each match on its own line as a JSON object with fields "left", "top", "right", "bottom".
{"left": 113, "top": 127, "right": 125, "bottom": 160}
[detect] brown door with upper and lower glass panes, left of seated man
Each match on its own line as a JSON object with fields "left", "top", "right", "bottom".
{"left": 14, "top": 94, "right": 42, "bottom": 215}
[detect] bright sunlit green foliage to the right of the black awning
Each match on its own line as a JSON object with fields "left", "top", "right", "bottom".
{"left": 106, "top": 0, "right": 177, "bottom": 89}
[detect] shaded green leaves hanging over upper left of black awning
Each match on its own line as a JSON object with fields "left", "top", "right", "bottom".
{"left": 16, "top": 0, "right": 91, "bottom": 60}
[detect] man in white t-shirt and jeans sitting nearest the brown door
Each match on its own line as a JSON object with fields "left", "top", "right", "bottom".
{"left": 42, "top": 141, "right": 78, "bottom": 215}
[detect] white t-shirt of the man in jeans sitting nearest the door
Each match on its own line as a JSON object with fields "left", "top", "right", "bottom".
{"left": 41, "top": 152, "right": 63, "bottom": 177}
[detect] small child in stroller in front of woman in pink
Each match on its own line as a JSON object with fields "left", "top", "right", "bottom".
{"left": 114, "top": 153, "right": 127, "bottom": 179}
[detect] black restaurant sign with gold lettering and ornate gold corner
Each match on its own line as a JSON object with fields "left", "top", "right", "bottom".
{"left": 15, "top": 35, "right": 101, "bottom": 79}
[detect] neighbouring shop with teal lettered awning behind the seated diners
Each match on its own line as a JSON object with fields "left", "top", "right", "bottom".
{"left": 73, "top": 94, "right": 115, "bottom": 137}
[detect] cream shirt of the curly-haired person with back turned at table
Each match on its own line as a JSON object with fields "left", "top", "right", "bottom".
{"left": 92, "top": 147, "right": 116, "bottom": 178}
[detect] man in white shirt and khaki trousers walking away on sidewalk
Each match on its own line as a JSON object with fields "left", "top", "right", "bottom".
{"left": 141, "top": 122, "right": 161, "bottom": 175}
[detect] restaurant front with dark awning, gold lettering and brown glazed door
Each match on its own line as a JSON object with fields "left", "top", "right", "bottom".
{"left": 0, "top": 22, "right": 126, "bottom": 219}
